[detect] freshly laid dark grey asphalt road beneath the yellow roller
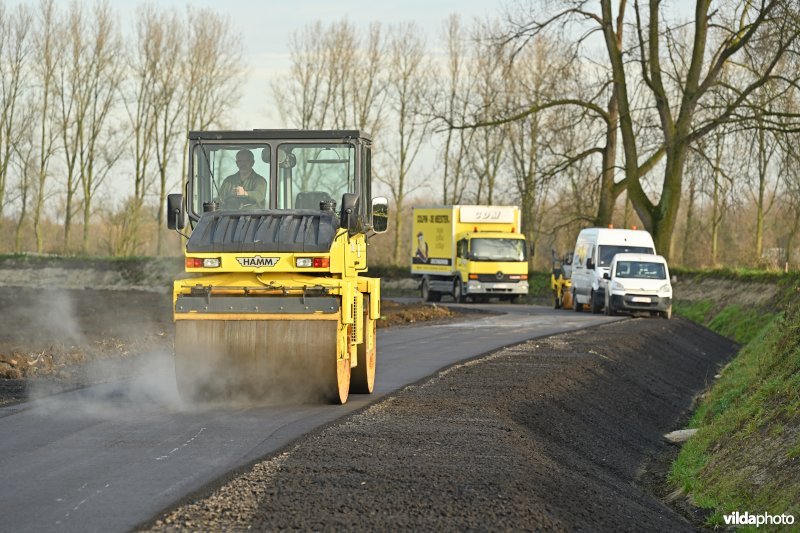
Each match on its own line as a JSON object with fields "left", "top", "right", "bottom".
{"left": 0, "top": 291, "right": 617, "bottom": 532}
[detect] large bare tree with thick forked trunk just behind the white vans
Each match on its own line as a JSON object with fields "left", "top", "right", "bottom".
{"left": 591, "top": 0, "right": 800, "bottom": 256}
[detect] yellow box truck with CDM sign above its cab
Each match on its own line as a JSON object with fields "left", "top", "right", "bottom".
{"left": 411, "top": 205, "right": 528, "bottom": 302}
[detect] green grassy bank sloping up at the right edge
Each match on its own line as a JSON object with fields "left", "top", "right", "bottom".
{"left": 669, "top": 287, "right": 800, "bottom": 531}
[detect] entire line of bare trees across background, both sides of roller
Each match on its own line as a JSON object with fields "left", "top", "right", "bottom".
{"left": 0, "top": 0, "right": 800, "bottom": 267}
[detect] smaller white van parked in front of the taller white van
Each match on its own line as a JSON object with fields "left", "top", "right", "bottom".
{"left": 603, "top": 254, "right": 672, "bottom": 318}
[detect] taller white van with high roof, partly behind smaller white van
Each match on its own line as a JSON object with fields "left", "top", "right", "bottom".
{"left": 572, "top": 228, "right": 656, "bottom": 313}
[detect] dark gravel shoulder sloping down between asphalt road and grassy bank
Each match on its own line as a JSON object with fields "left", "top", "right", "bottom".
{"left": 142, "top": 319, "right": 738, "bottom": 531}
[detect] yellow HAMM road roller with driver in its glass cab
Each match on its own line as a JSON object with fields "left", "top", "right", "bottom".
{"left": 167, "top": 130, "right": 388, "bottom": 404}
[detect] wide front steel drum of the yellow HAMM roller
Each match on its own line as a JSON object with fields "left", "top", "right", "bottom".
{"left": 175, "top": 320, "right": 350, "bottom": 404}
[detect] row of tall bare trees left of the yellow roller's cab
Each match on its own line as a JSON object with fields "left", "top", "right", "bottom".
{"left": 0, "top": 0, "right": 242, "bottom": 255}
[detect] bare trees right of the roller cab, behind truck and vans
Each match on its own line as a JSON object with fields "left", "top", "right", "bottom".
{"left": 273, "top": 0, "right": 800, "bottom": 264}
